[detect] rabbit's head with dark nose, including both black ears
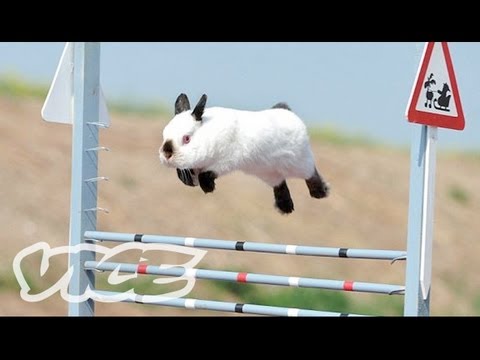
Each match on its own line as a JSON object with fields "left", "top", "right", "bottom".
{"left": 158, "top": 94, "right": 207, "bottom": 169}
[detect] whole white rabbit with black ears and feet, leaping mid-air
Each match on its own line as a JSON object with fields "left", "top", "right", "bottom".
{"left": 159, "top": 93, "right": 330, "bottom": 214}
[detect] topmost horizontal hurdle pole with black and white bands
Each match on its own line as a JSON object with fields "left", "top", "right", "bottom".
{"left": 84, "top": 231, "right": 407, "bottom": 261}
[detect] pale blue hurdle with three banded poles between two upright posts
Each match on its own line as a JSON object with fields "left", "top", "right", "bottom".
{"left": 42, "top": 43, "right": 458, "bottom": 316}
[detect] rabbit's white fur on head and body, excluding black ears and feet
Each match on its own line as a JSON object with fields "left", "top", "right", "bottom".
{"left": 159, "top": 107, "right": 316, "bottom": 187}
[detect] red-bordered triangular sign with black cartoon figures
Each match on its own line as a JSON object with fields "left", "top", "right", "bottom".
{"left": 406, "top": 42, "right": 465, "bottom": 130}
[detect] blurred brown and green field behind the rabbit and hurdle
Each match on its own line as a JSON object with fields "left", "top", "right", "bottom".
{"left": 0, "top": 75, "right": 480, "bottom": 316}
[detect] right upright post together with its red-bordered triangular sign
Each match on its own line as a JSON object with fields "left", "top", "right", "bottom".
{"left": 404, "top": 42, "right": 465, "bottom": 316}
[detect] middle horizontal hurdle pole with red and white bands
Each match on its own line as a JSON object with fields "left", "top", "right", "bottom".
{"left": 84, "top": 261, "right": 405, "bottom": 295}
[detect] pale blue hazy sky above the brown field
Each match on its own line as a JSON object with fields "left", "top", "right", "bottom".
{"left": 0, "top": 42, "right": 480, "bottom": 150}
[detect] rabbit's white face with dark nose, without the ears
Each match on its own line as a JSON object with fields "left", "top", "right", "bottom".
{"left": 159, "top": 111, "right": 201, "bottom": 168}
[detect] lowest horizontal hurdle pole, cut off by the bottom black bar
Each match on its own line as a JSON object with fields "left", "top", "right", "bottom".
{"left": 92, "top": 290, "right": 365, "bottom": 317}
